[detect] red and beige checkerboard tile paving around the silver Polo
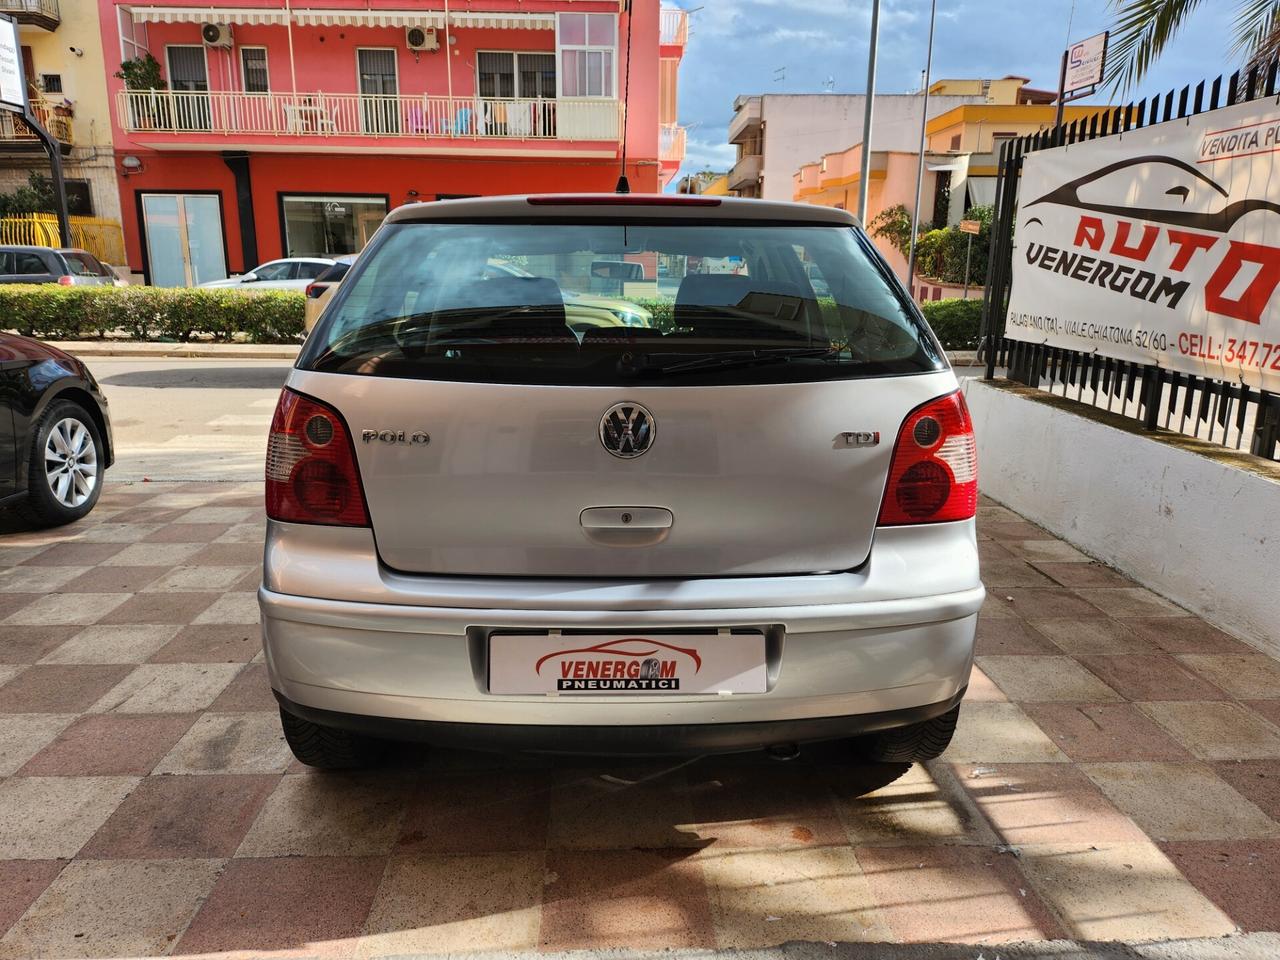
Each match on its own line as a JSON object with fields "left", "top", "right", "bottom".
{"left": 0, "top": 483, "right": 1280, "bottom": 960}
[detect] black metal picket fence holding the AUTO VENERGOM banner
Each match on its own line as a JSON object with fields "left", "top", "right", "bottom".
{"left": 982, "top": 61, "right": 1280, "bottom": 460}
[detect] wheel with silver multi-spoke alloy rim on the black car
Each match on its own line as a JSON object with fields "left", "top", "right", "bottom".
{"left": 26, "top": 399, "right": 106, "bottom": 526}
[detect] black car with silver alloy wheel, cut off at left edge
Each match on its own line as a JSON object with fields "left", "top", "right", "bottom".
{"left": 0, "top": 333, "right": 114, "bottom": 526}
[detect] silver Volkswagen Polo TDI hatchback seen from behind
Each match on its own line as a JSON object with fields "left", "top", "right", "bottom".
{"left": 260, "top": 195, "right": 983, "bottom": 767}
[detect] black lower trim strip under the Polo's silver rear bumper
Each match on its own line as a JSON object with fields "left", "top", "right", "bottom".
{"left": 275, "top": 689, "right": 965, "bottom": 756}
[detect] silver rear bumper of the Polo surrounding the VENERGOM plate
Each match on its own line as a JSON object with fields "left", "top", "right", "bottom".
{"left": 259, "top": 522, "right": 984, "bottom": 751}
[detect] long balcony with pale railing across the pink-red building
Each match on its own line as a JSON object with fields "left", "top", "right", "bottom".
{"left": 116, "top": 90, "right": 621, "bottom": 145}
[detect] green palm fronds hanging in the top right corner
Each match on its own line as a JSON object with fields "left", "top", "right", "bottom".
{"left": 1107, "top": 0, "right": 1280, "bottom": 92}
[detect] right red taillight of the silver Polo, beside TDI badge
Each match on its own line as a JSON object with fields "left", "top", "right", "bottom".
{"left": 877, "top": 390, "right": 978, "bottom": 526}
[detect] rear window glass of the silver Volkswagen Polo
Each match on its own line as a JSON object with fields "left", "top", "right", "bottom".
{"left": 298, "top": 221, "right": 942, "bottom": 385}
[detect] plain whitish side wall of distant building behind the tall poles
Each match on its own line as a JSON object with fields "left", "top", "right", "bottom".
{"left": 760, "top": 93, "right": 986, "bottom": 200}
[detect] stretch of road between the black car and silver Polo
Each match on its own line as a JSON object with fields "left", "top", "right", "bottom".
{"left": 86, "top": 357, "right": 289, "bottom": 481}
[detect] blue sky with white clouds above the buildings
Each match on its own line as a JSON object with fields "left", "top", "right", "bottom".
{"left": 664, "top": 0, "right": 1235, "bottom": 181}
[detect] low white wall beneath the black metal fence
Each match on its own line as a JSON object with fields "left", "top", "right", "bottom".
{"left": 965, "top": 380, "right": 1280, "bottom": 655}
